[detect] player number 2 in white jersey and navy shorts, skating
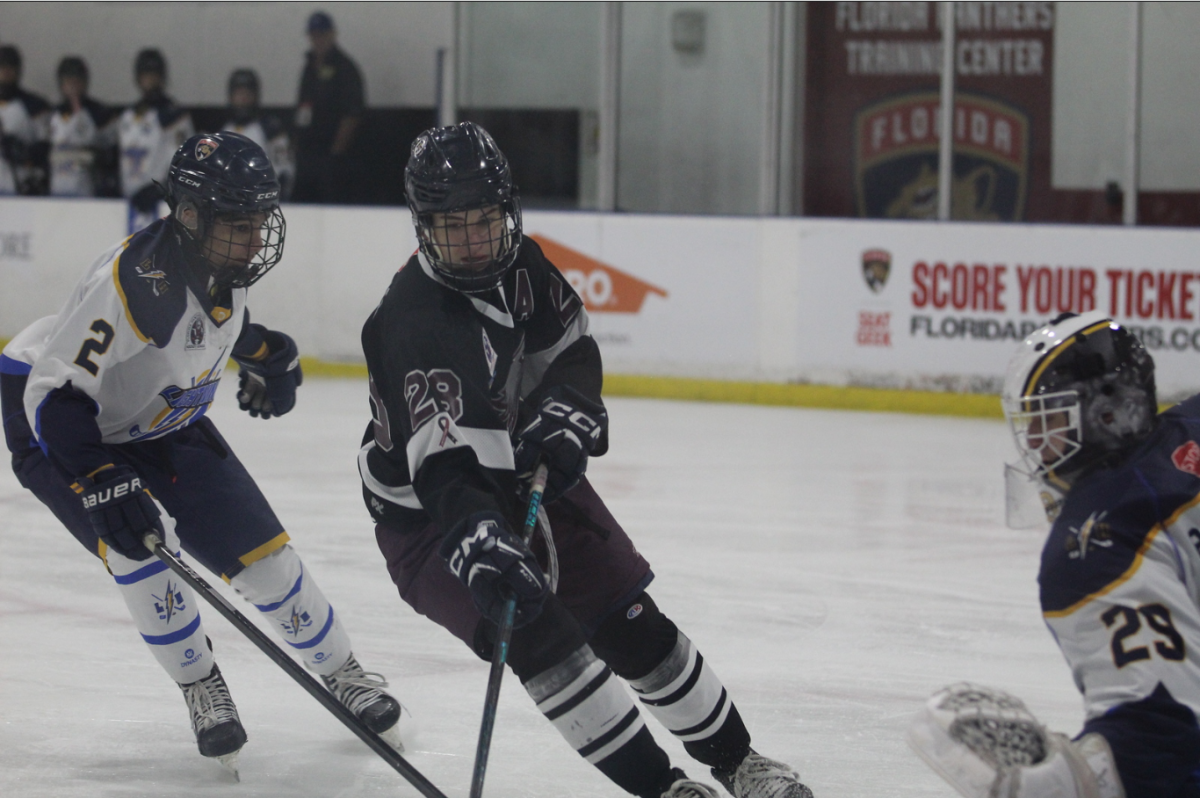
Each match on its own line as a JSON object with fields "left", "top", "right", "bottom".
{"left": 0, "top": 133, "right": 401, "bottom": 763}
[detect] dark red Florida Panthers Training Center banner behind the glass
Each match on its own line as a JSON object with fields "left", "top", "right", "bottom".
{"left": 804, "top": 2, "right": 1055, "bottom": 222}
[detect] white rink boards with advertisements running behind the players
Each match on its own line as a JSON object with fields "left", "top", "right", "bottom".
{"left": 0, "top": 198, "right": 1200, "bottom": 403}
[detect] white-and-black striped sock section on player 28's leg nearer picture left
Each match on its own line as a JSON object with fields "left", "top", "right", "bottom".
{"left": 524, "top": 643, "right": 646, "bottom": 766}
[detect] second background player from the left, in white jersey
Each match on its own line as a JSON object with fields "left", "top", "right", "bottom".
{"left": 50, "top": 55, "right": 116, "bottom": 197}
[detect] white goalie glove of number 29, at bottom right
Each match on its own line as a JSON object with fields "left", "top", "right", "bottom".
{"left": 907, "top": 682, "right": 1124, "bottom": 798}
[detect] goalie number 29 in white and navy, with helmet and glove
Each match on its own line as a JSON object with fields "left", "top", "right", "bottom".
{"left": 910, "top": 311, "right": 1200, "bottom": 798}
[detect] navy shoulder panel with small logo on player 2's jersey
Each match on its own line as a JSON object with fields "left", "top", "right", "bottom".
{"left": 113, "top": 220, "right": 187, "bottom": 349}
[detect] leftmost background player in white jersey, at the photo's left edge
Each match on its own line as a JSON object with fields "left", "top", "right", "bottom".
{"left": 0, "top": 44, "right": 50, "bottom": 194}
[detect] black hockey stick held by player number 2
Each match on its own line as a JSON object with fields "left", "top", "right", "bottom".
{"left": 143, "top": 532, "right": 446, "bottom": 798}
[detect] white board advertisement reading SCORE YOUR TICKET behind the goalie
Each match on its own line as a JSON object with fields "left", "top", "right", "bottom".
{"left": 798, "top": 221, "right": 1200, "bottom": 398}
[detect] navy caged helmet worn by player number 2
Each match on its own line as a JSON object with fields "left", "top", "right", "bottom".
{"left": 167, "top": 131, "right": 286, "bottom": 288}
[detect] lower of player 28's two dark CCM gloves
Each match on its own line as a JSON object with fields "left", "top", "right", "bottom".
{"left": 438, "top": 512, "right": 550, "bottom": 629}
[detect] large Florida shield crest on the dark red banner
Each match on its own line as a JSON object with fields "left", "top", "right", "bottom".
{"left": 854, "top": 91, "right": 1030, "bottom": 222}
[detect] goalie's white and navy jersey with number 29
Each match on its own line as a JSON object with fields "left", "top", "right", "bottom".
{"left": 1038, "top": 396, "right": 1200, "bottom": 797}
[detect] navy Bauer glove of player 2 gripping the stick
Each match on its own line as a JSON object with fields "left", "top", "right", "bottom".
{"left": 79, "top": 466, "right": 166, "bottom": 560}
